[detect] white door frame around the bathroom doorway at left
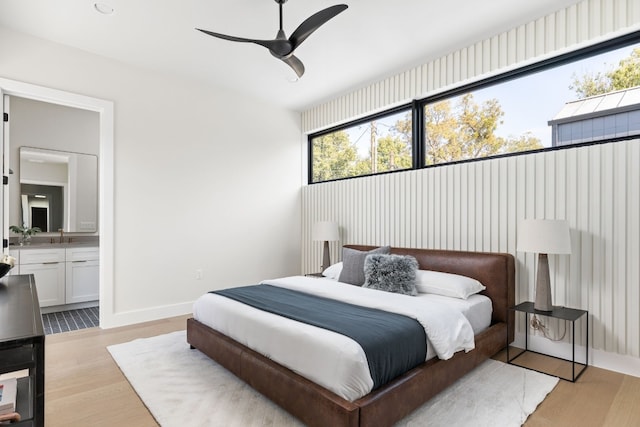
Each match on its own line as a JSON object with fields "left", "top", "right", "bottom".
{"left": 0, "top": 77, "right": 116, "bottom": 328}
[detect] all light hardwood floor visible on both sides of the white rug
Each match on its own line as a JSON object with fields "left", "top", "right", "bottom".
{"left": 45, "top": 316, "right": 640, "bottom": 427}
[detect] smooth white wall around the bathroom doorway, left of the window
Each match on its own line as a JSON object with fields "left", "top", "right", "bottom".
{"left": 0, "top": 28, "right": 301, "bottom": 326}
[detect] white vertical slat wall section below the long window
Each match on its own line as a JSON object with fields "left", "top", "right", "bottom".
{"left": 302, "top": 140, "right": 640, "bottom": 357}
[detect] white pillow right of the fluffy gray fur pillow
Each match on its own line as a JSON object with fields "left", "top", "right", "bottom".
{"left": 416, "top": 270, "right": 486, "bottom": 299}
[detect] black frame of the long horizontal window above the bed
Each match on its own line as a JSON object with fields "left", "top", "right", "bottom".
{"left": 307, "top": 30, "right": 640, "bottom": 185}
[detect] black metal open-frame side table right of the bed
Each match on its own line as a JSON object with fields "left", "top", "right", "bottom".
{"left": 507, "top": 301, "right": 589, "bottom": 382}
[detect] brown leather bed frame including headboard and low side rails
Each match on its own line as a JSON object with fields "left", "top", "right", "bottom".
{"left": 187, "top": 245, "right": 515, "bottom": 427}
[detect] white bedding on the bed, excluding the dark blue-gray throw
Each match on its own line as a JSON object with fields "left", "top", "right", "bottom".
{"left": 193, "top": 276, "right": 491, "bottom": 401}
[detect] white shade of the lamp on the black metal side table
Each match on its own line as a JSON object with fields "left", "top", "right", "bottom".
{"left": 517, "top": 219, "right": 571, "bottom": 254}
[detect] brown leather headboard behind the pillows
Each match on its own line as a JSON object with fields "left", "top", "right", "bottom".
{"left": 345, "top": 245, "right": 515, "bottom": 331}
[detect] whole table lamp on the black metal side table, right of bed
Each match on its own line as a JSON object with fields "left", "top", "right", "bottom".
{"left": 517, "top": 219, "right": 571, "bottom": 311}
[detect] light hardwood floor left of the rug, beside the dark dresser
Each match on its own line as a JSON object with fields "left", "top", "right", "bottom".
{"left": 45, "top": 316, "right": 188, "bottom": 427}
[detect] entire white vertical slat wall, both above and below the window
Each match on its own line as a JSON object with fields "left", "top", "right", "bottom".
{"left": 302, "top": 0, "right": 640, "bottom": 357}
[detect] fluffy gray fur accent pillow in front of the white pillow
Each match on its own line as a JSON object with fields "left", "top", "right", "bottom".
{"left": 362, "top": 254, "right": 418, "bottom": 296}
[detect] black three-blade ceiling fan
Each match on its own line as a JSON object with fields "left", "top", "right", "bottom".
{"left": 196, "top": 0, "right": 348, "bottom": 77}
